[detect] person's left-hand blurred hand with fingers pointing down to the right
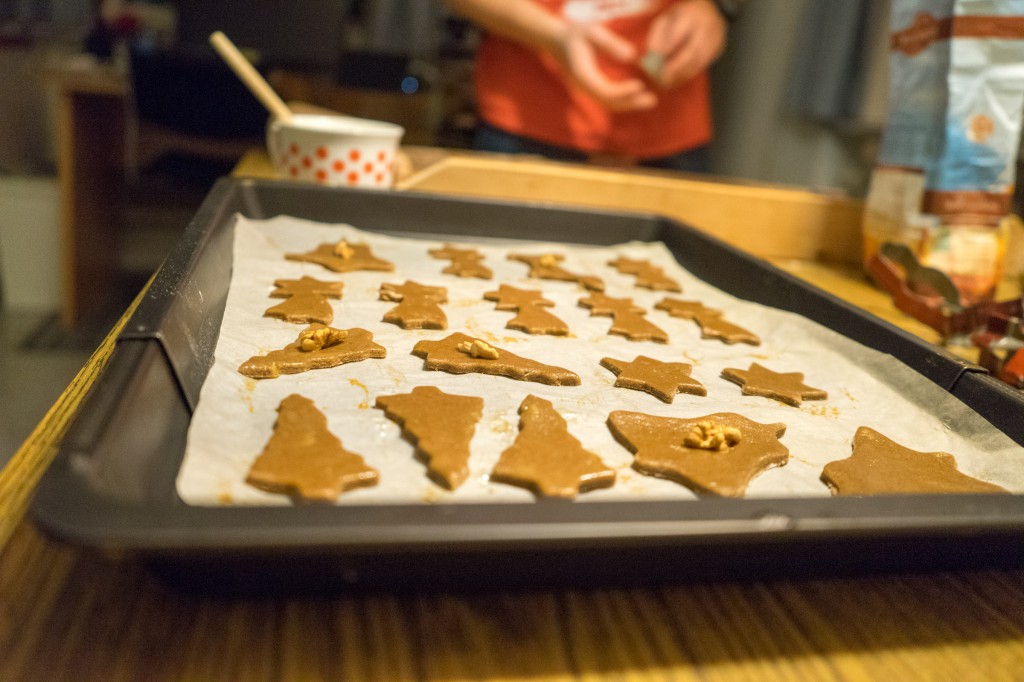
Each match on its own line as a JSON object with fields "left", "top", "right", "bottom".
{"left": 556, "top": 24, "right": 657, "bottom": 112}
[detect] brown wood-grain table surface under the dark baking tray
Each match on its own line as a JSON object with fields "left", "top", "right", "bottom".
{"left": 0, "top": 151, "right": 1024, "bottom": 681}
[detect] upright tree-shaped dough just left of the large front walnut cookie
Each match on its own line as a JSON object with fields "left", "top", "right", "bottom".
{"left": 490, "top": 395, "right": 615, "bottom": 499}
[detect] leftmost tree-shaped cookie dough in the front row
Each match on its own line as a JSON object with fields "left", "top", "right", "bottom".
{"left": 246, "top": 393, "right": 379, "bottom": 502}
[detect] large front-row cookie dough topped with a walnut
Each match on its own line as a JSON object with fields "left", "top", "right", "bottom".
{"left": 608, "top": 411, "right": 790, "bottom": 498}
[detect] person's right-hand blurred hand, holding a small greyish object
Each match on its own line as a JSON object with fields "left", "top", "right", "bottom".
{"left": 647, "top": 0, "right": 726, "bottom": 88}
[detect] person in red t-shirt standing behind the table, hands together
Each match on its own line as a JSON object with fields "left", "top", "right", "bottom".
{"left": 447, "top": 0, "right": 741, "bottom": 171}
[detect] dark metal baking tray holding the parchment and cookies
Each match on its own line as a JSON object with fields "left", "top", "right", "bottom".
{"left": 32, "top": 178, "right": 1024, "bottom": 592}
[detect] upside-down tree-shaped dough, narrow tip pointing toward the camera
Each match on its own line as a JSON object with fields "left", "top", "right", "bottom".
{"left": 376, "top": 386, "right": 483, "bottom": 491}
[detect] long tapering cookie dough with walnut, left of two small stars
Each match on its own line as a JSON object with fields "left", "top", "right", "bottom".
{"left": 413, "top": 332, "right": 580, "bottom": 386}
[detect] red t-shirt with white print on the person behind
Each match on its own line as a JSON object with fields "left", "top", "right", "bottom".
{"left": 476, "top": 0, "right": 712, "bottom": 159}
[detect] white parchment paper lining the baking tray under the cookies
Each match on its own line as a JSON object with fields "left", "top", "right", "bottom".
{"left": 177, "top": 216, "right": 1024, "bottom": 505}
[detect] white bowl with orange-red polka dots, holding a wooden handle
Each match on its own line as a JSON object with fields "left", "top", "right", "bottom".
{"left": 266, "top": 114, "right": 406, "bottom": 189}
